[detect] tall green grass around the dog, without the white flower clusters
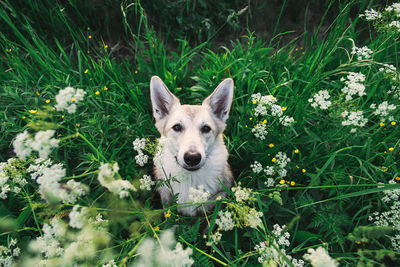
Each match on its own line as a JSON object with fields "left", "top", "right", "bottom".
{"left": 0, "top": 1, "right": 400, "bottom": 266}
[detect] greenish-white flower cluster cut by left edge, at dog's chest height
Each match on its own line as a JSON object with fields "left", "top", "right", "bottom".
{"left": 0, "top": 158, "right": 28, "bottom": 199}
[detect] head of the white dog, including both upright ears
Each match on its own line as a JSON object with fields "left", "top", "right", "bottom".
{"left": 150, "top": 76, "right": 233, "bottom": 171}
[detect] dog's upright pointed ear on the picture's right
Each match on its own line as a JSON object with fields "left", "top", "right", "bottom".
{"left": 203, "top": 78, "right": 233, "bottom": 122}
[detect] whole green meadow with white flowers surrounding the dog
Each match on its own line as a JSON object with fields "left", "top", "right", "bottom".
{"left": 0, "top": 0, "right": 400, "bottom": 267}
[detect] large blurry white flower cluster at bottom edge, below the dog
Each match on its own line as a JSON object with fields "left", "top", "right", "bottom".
{"left": 133, "top": 230, "right": 194, "bottom": 267}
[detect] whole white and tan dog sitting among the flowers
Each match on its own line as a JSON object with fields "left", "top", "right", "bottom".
{"left": 150, "top": 76, "right": 234, "bottom": 216}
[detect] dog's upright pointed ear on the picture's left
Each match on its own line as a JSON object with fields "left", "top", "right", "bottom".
{"left": 150, "top": 76, "right": 180, "bottom": 120}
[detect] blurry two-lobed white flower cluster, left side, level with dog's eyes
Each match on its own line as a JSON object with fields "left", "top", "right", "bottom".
{"left": 13, "top": 130, "right": 59, "bottom": 159}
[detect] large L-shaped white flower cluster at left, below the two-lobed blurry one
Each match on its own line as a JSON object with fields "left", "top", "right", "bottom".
{"left": 27, "top": 158, "right": 88, "bottom": 204}
